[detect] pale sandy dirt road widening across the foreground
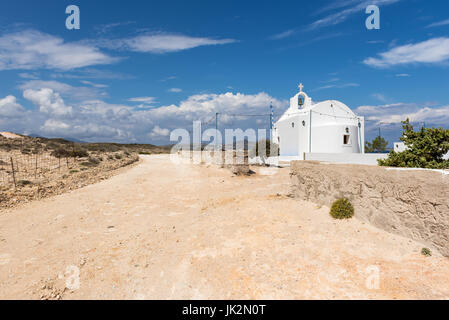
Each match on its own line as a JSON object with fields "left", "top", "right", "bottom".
{"left": 0, "top": 156, "right": 449, "bottom": 299}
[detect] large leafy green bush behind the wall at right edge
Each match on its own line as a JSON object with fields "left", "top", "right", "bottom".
{"left": 378, "top": 119, "right": 449, "bottom": 169}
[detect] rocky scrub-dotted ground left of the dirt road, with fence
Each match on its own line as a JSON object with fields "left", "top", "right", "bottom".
{"left": 0, "top": 132, "right": 169, "bottom": 210}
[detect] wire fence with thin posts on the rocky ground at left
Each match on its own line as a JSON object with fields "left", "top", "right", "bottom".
{"left": 0, "top": 151, "right": 76, "bottom": 188}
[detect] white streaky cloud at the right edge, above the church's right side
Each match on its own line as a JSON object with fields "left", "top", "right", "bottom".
{"left": 363, "top": 37, "right": 449, "bottom": 68}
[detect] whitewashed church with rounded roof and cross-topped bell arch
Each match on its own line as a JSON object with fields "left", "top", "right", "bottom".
{"left": 272, "top": 84, "right": 365, "bottom": 160}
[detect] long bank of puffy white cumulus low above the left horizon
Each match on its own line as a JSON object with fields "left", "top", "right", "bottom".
{"left": 0, "top": 88, "right": 287, "bottom": 144}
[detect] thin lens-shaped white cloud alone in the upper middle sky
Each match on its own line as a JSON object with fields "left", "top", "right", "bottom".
{"left": 114, "top": 33, "right": 236, "bottom": 53}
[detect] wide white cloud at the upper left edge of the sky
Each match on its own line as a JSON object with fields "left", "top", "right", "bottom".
{"left": 0, "top": 30, "right": 118, "bottom": 70}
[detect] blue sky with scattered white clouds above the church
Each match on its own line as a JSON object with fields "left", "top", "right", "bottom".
{"left": 0, "top": 0, "right": 449, "bottom": 144}
